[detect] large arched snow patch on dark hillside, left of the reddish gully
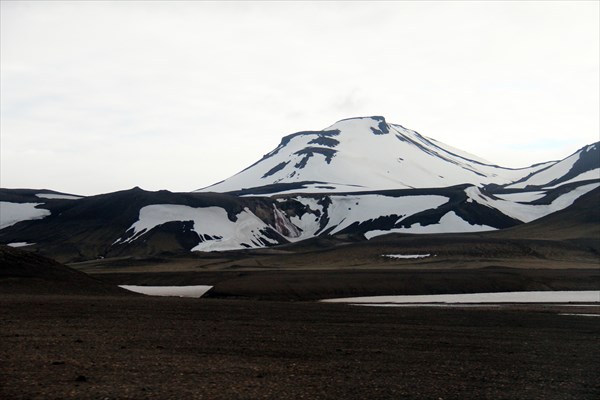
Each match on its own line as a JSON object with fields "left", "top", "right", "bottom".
{"left": 114, "top": 204, "right": 277, "bottom": 251}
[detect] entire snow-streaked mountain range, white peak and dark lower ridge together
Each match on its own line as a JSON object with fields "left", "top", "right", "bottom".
{"left": 0, "top": 117, "right": 600, "bottom": 261}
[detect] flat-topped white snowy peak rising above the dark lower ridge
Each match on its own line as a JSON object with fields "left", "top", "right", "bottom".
{"left": 199, "top": 116, "right": 552, "bottom": 194}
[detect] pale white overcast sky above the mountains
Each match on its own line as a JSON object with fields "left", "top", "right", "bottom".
{"left": 0, "top": 0, "right": 600, "bottom": 195}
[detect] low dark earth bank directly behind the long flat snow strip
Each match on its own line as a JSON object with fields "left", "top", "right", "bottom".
{"left": 91, "top": 267, "right": 600, "bottom": 301}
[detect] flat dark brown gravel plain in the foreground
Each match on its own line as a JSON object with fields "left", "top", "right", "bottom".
{"left": 0, "top": 295, "right": 600, "bottom": 399}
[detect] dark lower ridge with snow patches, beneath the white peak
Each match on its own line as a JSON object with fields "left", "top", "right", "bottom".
{"left": 0, "top": 183, "right": 599, "bottom": 262}
